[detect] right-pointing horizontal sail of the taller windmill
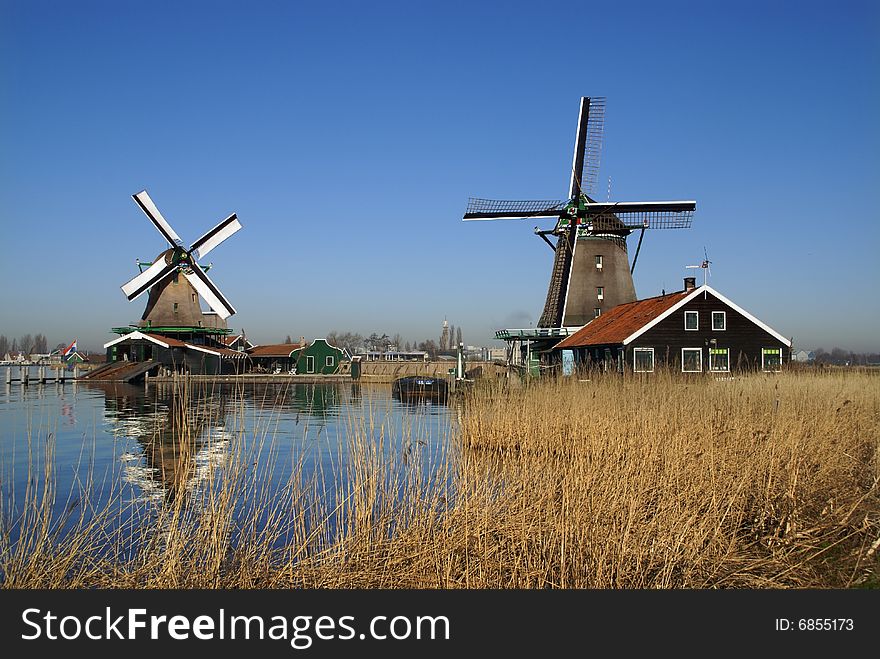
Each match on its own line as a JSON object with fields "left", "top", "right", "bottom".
{"left": 584, "top": 201, "right": 697, "bottom": 230}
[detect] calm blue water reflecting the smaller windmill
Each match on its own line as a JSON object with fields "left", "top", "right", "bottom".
{"left": 0, "top": 367, "right": 454, "bottom": 548}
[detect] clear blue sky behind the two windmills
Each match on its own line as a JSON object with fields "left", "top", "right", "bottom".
{"left": 0, "top": 0, "right": 880, "bottom": 351}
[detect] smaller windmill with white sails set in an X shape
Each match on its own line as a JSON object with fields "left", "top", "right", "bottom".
{"left": 122, "top": 190, "right": 241, "bottom": 328}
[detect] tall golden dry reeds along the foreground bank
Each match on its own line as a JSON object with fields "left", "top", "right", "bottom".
{"left": 0, "top": 371, "right": 880, "bottom": 588}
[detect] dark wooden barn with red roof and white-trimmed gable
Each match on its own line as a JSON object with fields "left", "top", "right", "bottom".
{"left": 554, "top": 277, "right": 791, "bottom": 373}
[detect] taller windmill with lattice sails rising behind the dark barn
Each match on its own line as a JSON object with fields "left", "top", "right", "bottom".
{"left": 463, "top": 97, "right": 696, "bottom": 332}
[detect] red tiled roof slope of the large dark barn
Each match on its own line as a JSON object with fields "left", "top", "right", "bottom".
{"left": 555, "top": 291, "right": 693, "bottom": 349}
